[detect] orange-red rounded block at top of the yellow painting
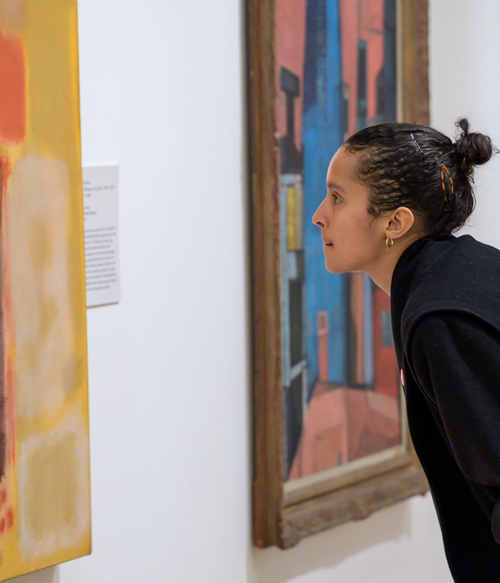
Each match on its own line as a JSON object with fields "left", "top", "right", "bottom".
{"left": 0, "top": 30, "right": 26, "bottom": 145}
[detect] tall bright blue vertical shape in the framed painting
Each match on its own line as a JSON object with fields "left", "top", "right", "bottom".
{"left": 303, "top": 0, "right": 348, "bottom": 395}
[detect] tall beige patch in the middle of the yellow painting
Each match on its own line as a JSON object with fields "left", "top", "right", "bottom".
{"left": 7, "top": 155, "right": 85, "bottom": 417}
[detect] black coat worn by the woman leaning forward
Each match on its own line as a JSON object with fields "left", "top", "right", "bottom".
{"left": 391, "top": 235, "right": 500, "bottom": 583}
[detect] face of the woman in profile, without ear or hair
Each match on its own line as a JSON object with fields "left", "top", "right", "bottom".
{"left": 312, "top": 146, "right": 387, "bottom": 273}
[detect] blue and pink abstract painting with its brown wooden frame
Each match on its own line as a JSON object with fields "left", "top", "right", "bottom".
{"left": 247, "top": 0, "right": 429, "bottom": 548}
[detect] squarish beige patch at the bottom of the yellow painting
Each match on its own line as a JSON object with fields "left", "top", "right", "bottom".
{"left": 18, "top": 413, "right": 90, "bottom": 558}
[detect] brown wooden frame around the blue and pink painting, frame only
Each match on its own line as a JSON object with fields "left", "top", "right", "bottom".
{"left": 247, "top": 0, "right": 429, "bottom": 549}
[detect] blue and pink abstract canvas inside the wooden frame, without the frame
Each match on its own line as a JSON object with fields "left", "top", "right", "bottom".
{"left": 276, "top": 0, "right": 402, "bottom": 481}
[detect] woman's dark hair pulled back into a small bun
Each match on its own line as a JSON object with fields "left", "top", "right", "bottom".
{"left": 344, "top": 119, "right": 496, "bottom": 235}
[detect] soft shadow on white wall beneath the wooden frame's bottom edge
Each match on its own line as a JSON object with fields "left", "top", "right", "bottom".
{"left": 248, "top": 502, "right": 411, "bottom": 583}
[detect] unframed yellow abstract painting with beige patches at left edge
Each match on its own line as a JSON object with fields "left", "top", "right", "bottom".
{"left": 0, "top": 0, "right": 90, "bottom": 581}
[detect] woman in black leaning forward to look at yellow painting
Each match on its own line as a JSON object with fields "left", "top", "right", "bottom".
{"left": 313, "top": 119, "right": 500, "bottom": 583}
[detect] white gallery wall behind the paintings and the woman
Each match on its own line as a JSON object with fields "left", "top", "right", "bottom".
{"left": 10, "top": 0, "right": 500, "bottom": 583}
